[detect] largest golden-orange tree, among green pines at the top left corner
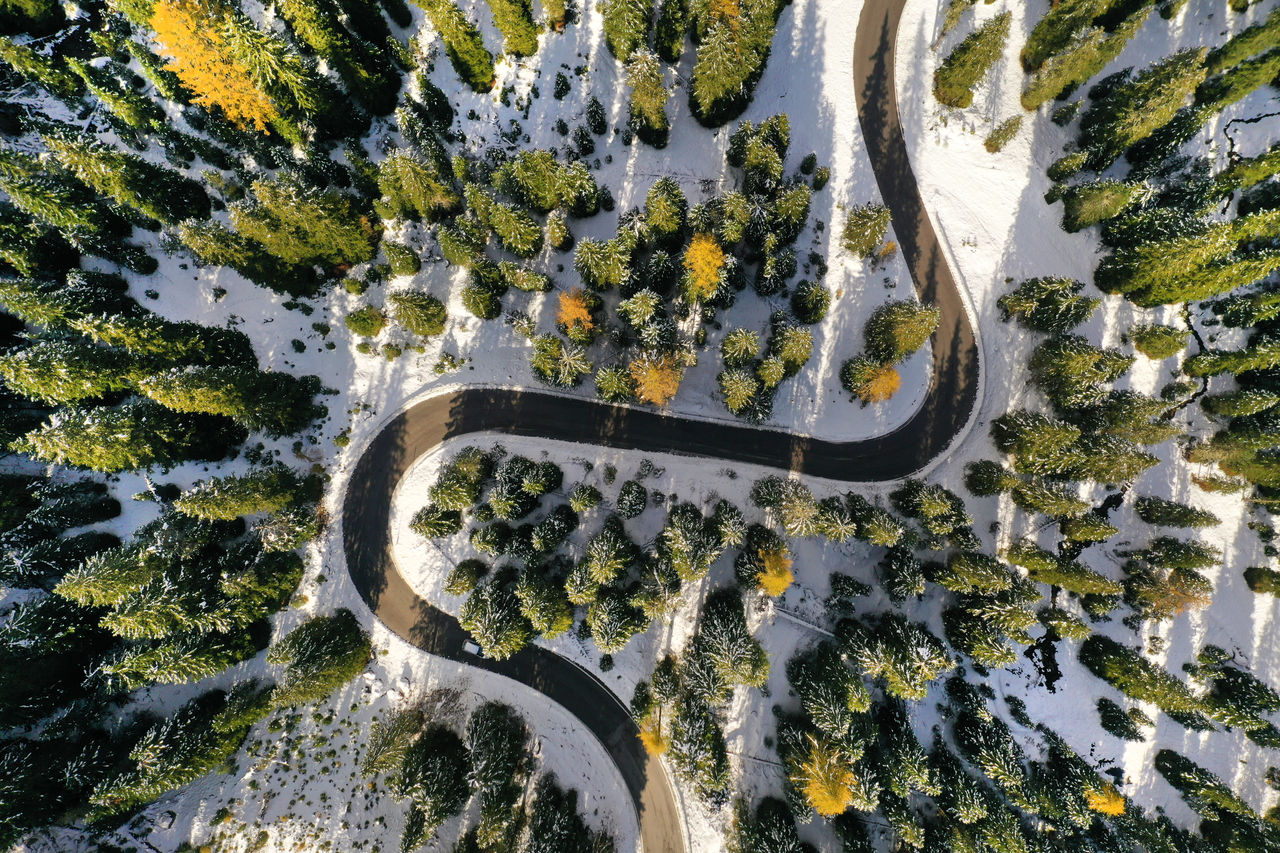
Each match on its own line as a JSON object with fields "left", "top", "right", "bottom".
{"left": 151, "top": 0, "right": 279, "bottom": 131}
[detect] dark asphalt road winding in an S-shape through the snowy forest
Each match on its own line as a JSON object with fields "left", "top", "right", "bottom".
{"left": 342, "top": 0, "right": 978, "bottom": 853}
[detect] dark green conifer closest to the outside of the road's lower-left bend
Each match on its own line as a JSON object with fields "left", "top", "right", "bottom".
{"left": 266, "top": 608, "right": 372, "bottom": 708}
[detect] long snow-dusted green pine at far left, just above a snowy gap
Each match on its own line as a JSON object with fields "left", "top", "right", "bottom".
{"left": 12, "top": 398, "right": 243, "bottom": 471}
